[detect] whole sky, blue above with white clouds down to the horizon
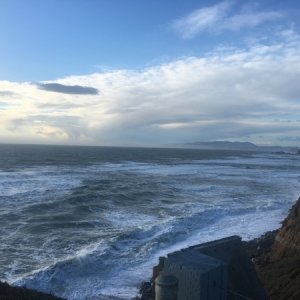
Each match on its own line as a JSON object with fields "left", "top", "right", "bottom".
{"left": 0, "top": 0, "right": 300, "bottom": 146}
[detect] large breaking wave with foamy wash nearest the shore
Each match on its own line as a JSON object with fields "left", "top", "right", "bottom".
{"left": 15, "top": 203, "right": 296, "bottom": 300}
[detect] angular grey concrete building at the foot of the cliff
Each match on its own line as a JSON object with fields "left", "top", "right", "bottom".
{"left": 154, "top": 236, "right": 267, "bottom": 300}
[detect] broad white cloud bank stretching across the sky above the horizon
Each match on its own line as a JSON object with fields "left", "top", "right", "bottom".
{"left": 0, "top": 32, "right": 300, "bottom": 145}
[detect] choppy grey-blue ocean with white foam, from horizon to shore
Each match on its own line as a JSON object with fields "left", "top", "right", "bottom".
{"left": 0, "top": 145, "right": 300, "bottom": 300}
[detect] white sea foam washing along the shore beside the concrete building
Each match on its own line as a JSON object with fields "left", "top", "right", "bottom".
{"left": 88, "top": 210, "right": 285, "bottom": 299}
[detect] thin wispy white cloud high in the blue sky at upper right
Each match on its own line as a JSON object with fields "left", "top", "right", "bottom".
{"left": 171, "top": 1, "right": 284, "bottom": 39}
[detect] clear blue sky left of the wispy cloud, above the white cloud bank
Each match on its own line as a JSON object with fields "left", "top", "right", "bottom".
{"left": 0, "top": 0, "right": 209, "bottom": 81}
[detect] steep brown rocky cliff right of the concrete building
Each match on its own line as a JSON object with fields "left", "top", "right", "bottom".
{"left": 253, "top": 198, "right": 300, "bottom": 300}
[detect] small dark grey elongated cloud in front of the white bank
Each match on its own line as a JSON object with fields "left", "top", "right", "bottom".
{"left": 36, "top": 83, "right": 98, "bottom": 95}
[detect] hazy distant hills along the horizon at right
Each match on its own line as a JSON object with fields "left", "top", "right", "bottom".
{"left": 183, "top": 141, "right": 297, "bottom": 153}
